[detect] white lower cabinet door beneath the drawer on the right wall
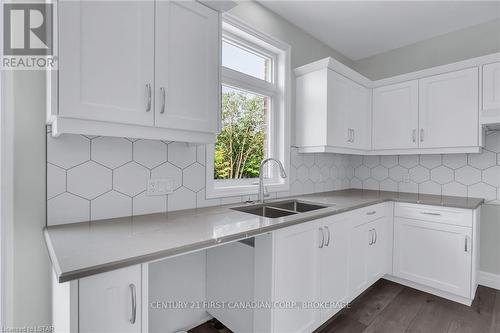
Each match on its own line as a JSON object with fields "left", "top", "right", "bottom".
{"left": 394, "top": 218, "right": 472, "bottom": 297}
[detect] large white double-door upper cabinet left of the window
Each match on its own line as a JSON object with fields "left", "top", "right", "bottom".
{"left": 48, "top": 1, "right": 220, "bottom": 142}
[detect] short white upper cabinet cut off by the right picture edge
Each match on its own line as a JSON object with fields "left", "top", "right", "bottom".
{"left": 481, "top": 62, "right": 500, "bottom": 124}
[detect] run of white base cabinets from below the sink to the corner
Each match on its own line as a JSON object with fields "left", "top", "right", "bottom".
{"left": 273, "top": 204, "right": 390, "bottom": 333}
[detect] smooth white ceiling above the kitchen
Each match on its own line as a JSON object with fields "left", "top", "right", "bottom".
{"left": 259, "top": 0, "right": 500, "bottom": 60}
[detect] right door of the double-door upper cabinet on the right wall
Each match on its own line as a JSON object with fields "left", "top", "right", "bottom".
{"left": 419, "top": 67, "right": 479, "bottom": 148}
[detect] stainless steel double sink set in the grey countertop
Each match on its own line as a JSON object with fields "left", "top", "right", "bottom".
{"left": 233, "top": 200, "right": 328, "bottom": 218}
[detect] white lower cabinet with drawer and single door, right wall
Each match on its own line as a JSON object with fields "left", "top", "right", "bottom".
{"left": 393, "top": 205, "right": 479, "bottom": 300}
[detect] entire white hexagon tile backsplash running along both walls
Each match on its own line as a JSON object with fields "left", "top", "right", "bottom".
{"left": 47, "top": 132, "right": 500, "bottom": 225}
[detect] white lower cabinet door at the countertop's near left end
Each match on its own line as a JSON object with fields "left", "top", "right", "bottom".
{"left": 78, "top": 265, "right": 142, "bottom": 333}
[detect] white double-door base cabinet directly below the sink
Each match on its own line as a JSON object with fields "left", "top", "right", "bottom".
{"left": 273, "top": 217, "right": 350, "bottom": 333}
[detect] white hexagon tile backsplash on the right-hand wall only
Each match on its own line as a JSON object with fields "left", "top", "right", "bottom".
{"left": 350, "top": 131, "right": 500, "bottom": 204}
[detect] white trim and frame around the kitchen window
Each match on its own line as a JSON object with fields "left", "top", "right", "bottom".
{"left": 206, "top": 14, "right": 291, "bottom": 198}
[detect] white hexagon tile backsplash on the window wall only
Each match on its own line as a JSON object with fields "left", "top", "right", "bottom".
{"left": 47, "top": 134, "right": 353, "bottom": 225}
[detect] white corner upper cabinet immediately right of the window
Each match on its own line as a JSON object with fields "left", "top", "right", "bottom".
{"left": 296, "top": 63, "right": 371, "bottom": 153}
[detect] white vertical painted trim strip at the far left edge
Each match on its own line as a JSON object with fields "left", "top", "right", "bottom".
{"left": 0, "top": 71, "right": 14, "bottom": 326}
